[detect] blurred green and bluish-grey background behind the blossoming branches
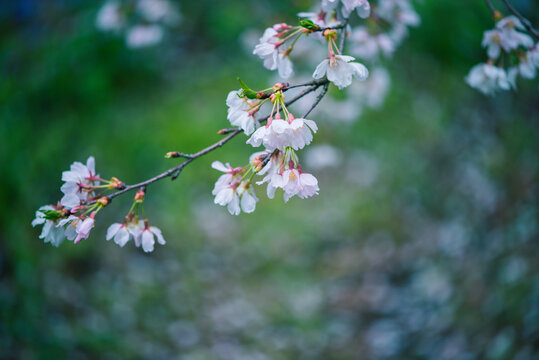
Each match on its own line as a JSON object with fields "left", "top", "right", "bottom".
{"left": 0, "top": 0, "right": 539, "bottom": 360}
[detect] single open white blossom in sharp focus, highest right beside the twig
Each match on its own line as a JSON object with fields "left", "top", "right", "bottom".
{"left": 313, "top": 55, "right": 369, "bottom": 89}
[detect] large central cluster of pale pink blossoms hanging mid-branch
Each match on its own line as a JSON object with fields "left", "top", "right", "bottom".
{"left": 212, "top": 88, "right": 319, "bottom": 215}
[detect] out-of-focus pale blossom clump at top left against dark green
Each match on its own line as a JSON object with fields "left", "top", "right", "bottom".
{"left": 96, "top": 0, "right": 181, "bottom": 48}
